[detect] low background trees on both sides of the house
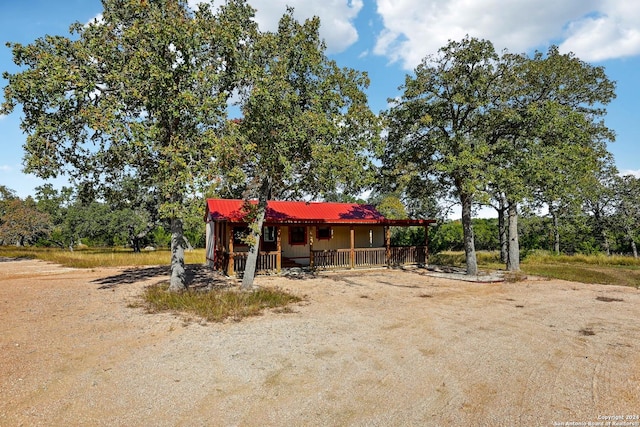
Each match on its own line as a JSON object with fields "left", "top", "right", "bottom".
{"left": 0, "top": 176, "right": 640, "bottom": 257}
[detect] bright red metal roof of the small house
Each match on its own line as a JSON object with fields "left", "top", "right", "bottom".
{"left": 207, "top": 199, "right": 386, "bottom": 224}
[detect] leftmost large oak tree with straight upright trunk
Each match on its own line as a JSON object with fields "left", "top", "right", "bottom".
{"left": 0, "top": 0, "right": 256, "bottom": 288}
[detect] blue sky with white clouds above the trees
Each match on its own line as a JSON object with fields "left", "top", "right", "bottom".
{"left": 0, "top": 0, "right": 640, "bottom": 201}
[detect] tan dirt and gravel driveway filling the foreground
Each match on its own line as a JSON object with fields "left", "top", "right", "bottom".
{"left": 0, "top": 260, "right": 640, "bottom": 426}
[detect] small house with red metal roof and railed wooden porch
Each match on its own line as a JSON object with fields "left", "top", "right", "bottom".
{"left": 205, "top": 199, "right": 435, "bottom": 276}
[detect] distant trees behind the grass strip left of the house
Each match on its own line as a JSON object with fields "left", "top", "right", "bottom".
{"left": 0, "top": 184, "right": 204, "bottom": 251}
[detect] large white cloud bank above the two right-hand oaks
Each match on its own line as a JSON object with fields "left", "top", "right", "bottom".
{"left": 374, "top": 0, "right": 640, "bottom": 69}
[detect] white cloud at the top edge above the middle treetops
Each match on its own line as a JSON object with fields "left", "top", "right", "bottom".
{"left": 188, "top": 0, "right": 363, "bottom": 53}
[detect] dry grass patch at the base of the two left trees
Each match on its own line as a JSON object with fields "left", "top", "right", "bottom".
{"left": 142, "top": 284, "right": 301, "bottom": 322}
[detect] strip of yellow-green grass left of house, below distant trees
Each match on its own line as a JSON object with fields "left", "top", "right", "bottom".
{"left": 0, "top": 246, "right": 205, "bottom": 268}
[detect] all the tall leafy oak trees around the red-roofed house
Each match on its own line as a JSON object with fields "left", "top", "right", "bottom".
{"left": 2, "top": 0, "right": 638, "bottom": 290}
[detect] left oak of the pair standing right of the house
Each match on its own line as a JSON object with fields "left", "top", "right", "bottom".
{"left": 383, "top": 37, "right": 499, "bottom": 275}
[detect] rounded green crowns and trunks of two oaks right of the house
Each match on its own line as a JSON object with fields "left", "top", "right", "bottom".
{"left": 382, "top": 37, "right": 616, "bottom": 270}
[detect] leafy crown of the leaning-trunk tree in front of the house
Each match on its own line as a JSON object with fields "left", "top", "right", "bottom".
{"left": 216, "top": 10, "right": 379, "bottom": 198}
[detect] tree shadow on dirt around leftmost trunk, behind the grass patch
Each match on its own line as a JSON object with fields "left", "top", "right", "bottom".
{"left": 92, "top": 264, "right": 234, "bottom": 290}
